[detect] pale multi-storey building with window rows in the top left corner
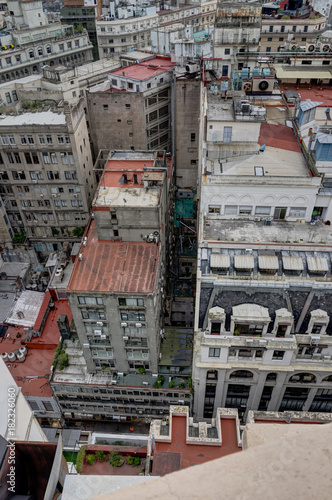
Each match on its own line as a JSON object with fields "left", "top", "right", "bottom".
{"left": 0, "top": 0, "right": 92, "bottom": 82}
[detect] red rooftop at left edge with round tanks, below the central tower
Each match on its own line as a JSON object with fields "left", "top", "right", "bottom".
{"left": 0, "top": 301, "right": 72, "bottom": 397}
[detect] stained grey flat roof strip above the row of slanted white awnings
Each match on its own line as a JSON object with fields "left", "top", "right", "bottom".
{"left": 204, "top": 219, "right": 332, "bottom": 251}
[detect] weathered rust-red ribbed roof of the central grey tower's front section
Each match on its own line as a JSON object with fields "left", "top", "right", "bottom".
{"left": 67, "top": 221, "right": 160, "bottom": 294}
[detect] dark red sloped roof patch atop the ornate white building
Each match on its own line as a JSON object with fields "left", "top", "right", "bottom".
{"left": 258, "top": 123, "right": 301, "bottom": 153}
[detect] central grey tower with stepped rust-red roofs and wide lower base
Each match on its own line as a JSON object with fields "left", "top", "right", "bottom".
{"left": 51, "top": 151, "right": 191, "bottom": 420}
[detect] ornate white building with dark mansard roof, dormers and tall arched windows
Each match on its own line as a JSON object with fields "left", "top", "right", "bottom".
{"left": 193, "top": 82, "right": 332, "bottom": 419}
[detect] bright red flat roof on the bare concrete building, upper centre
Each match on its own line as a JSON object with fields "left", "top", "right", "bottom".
{"left": 111, "top": 56, "right": 175, "bottom": 81}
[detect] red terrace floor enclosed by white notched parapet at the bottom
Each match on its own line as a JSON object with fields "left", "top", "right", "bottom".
{"left": 152, "top": 415, "right": 241, "bottom": 476}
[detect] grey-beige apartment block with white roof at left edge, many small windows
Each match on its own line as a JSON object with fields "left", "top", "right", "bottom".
{"left": 0, "top": 100, "right": 96, "bottom": 254}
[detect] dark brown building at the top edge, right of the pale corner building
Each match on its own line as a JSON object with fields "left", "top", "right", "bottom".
{"left": 61, "top": 0, "right": 102, "bottom": 61}
